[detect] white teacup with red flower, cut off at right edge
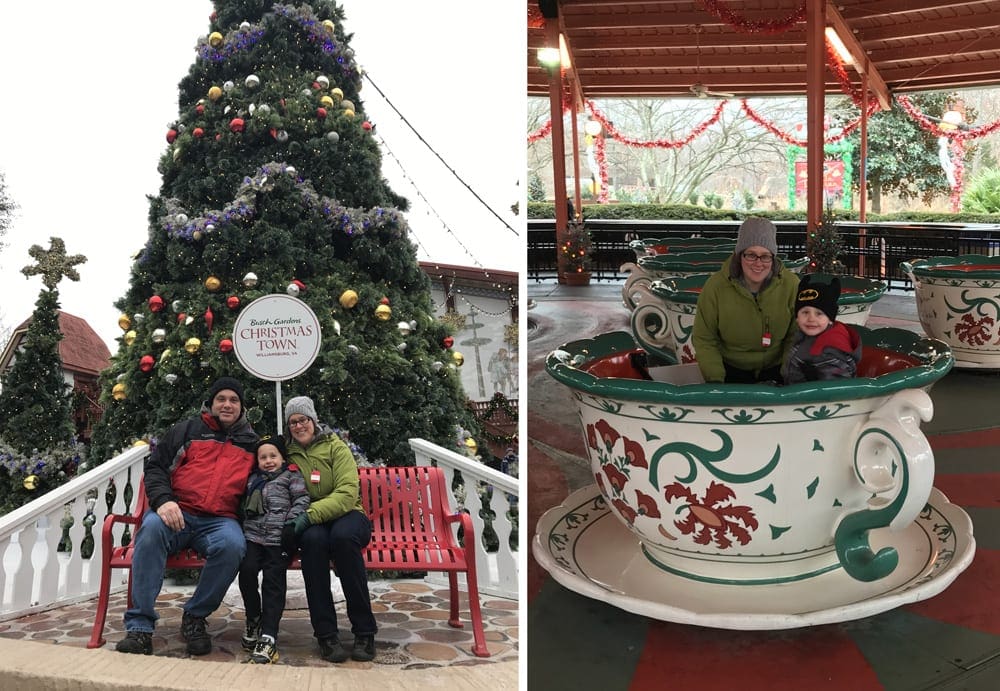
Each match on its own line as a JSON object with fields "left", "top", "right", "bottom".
{"left": 899, "top": 254, "right": 1000, "bottom": 369}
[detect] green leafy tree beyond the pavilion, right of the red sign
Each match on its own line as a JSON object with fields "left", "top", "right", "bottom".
{"left": 840, "top": 92, "right": 975, "bottom": 213}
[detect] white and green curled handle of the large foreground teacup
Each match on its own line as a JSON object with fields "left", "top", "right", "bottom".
{"left": 834, "top": 389, "right": 934, "bottom": 581}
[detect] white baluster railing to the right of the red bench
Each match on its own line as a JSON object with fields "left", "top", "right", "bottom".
{"left": 410, "top": 439, "right": 520, "bottom": 600}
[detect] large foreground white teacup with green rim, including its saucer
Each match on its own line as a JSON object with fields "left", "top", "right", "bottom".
{"left": 532, "top": 326, "right": 975, "bottom": 629}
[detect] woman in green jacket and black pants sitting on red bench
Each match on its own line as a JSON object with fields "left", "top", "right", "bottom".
{"left": 282, "top": 396, "right": 378, "bottom": 662}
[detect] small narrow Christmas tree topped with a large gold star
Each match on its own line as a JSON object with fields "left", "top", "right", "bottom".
{"left": 0, "top": 238, "right": 87, "bottom": 513}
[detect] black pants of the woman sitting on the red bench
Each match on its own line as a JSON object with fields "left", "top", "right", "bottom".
{"left": 299, "top": 511, "right": 378, "bottom": 638}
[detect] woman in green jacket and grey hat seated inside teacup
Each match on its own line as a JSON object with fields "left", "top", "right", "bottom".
{"left": 691, "top": 218, "right": 799, "bottom": 384}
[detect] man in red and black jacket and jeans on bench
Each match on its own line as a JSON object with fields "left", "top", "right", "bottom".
{"left": 115, "top": 377, "right": 257, "bottom": 655}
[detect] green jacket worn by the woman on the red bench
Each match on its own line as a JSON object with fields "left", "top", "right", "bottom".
{"left": 288, "top": 423, "right": 365, "bottom": 524}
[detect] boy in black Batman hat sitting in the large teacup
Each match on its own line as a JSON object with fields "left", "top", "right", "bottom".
{"left": 782, "top": 274, "right": 861, "bottom": 384}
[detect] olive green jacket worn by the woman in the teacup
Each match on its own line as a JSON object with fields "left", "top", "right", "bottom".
{"left": 691, "top": 258, "right": 799, "bottom": 382}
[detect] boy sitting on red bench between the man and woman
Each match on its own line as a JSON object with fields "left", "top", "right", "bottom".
{"left": 239, "top": 435, "right": 309, "bottom": 665}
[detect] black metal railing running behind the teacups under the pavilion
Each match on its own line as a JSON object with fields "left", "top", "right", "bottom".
{"left": 528, "top": 219, "right": 1000, "bottom": 289}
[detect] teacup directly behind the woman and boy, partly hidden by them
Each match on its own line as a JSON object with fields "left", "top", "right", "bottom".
{"left": 631, "top": 273, "right": 886, "bottom": 363}
